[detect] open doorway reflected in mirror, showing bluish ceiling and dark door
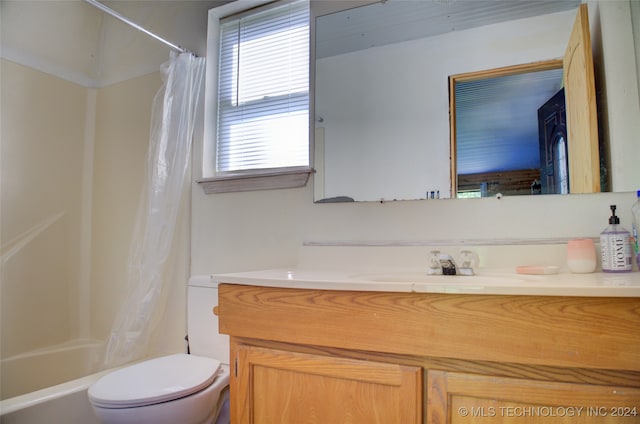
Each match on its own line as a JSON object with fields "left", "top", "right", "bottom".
{"left": 450, "top": 60, "right": 568, "bottom": 198}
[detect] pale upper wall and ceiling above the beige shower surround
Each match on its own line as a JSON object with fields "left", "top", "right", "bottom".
{"left": 0, "top": 0, "right": 228, "bottom": 87}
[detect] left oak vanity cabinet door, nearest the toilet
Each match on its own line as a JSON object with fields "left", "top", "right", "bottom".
{"left": 231, "top": 345, "right": 422, "bottom": 424}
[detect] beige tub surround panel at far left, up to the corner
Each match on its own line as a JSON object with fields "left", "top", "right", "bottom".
{"left": 0, "top": 60, "right": 88, "bottom": 357}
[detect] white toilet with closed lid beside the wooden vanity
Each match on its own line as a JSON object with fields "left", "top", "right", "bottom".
{"left": 89, "top": 277, "right": 229, "bottom": 424}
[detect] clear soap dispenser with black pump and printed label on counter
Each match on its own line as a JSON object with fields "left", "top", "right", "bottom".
{"left": 600, "top": 205, "right": 632, "bottom": 272}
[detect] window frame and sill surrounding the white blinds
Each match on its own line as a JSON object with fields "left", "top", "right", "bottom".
{"left": 196, "top": 0, "right": 314, "bottom": 194}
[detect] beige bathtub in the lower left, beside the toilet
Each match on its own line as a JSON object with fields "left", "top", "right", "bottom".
{"left": 0, "top": 340, "right": 111, "bottom": 424}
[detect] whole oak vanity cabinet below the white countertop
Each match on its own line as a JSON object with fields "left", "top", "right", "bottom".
{"left": 218, "top": 284, "right": 640, "bottom": 424}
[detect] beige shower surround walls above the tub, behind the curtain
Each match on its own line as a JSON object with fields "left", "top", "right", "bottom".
{"left": 0, "top": 59, "right": 156, "bottom": 398}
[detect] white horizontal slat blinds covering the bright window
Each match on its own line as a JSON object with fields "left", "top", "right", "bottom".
{"left": 216, "top": 1, "right": 309, "bottom": 173}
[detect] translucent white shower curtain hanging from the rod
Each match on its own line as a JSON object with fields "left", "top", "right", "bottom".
{"left": 105, "top": 53, "right": 205, "bottom": 366}
